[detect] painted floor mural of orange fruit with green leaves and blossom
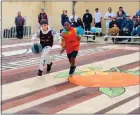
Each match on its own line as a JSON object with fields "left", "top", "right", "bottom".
{"left": 55, "top": 66, "right": 140, "bottom": 98}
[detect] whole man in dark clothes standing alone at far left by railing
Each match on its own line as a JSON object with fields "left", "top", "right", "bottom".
{"left": 15, "top": 12, "right": 25, "bottom": 39}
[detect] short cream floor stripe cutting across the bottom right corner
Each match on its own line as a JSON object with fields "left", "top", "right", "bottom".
{"left": 106, "top": 97, "right": 140, "bottom": 114}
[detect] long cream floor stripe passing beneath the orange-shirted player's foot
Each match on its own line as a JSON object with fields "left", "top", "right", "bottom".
{"left": 2, "top": 52, "right": 139, "bottom": 100}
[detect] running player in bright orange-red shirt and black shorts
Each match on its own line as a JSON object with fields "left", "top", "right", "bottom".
{"left": 60, "top": 22, "right": 83, "bottom": 76}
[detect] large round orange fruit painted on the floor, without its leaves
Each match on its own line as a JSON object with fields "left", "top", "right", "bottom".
{"left": 69, "top": 71, "right": 140, "bottom": 88}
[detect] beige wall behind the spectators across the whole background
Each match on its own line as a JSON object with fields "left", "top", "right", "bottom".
{"left": 2, "top": 2, "right": 139, "bottom": 33}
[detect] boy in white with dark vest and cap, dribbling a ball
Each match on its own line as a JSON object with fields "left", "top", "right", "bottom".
{"left": 32, "top": 19, "right": 61, "bottom": 76}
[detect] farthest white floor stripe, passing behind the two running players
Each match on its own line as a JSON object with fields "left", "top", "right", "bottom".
{"left": 2, "top": 43, "right": 86, "bottom": 57}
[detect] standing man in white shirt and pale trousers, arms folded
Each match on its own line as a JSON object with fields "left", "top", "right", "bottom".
{"left": 104, "top": 7, "right": 115, "bottom": 34}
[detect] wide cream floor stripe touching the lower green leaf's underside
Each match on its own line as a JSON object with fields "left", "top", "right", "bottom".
{"left": 57, "top": 85, "right": 139, "bottom": 114}
